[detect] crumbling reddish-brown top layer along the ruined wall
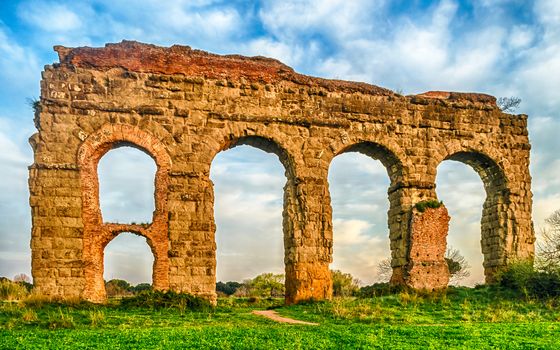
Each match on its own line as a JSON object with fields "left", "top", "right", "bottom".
{"left": 54, "top": 40, "right": 496, "bottom": 106}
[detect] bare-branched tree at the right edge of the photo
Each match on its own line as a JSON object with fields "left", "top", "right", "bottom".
{"left": 535, "top": 210, "right": 560, "bottom": 272}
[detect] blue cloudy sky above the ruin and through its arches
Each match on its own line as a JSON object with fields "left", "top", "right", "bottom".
{"left": 0, "top": 0, "right": 560, "bottom": 284}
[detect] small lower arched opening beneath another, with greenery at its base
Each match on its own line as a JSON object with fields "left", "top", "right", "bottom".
{"left": 103, "top": 232, "right": 154, "bottom": 297}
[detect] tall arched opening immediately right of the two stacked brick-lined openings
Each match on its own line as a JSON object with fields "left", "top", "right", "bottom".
{"left": 210, "top": 137, "right": 288, "bottom": 296}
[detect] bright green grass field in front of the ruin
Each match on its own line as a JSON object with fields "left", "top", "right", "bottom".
{"left": 0, "top": 288, "right": 560, "bottom": 349}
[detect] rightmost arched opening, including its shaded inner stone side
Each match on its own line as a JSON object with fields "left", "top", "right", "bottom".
{"left": 436, "top": 152, "right": 507, "bottom": 286}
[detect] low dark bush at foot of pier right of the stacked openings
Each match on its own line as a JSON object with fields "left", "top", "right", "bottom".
{"left": 120, "top": 290, "right": 211, "bottom": 311}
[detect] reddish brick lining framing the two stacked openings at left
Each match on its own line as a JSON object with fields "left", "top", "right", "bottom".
{"left": 77, "top": 124, "right": 171, "bottom": 302}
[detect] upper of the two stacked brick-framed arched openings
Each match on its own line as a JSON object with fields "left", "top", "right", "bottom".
{"left": 97, "top": 144, "right": 157, "bottom": 224}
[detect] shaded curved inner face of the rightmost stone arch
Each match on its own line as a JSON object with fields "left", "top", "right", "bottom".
{"left": 437, "top": 145, "right": 515, "bottom": 282}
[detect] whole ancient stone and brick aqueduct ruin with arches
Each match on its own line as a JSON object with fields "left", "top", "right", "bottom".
{"left": 29, "top": 41, "right": 534, "bottom": 303}
